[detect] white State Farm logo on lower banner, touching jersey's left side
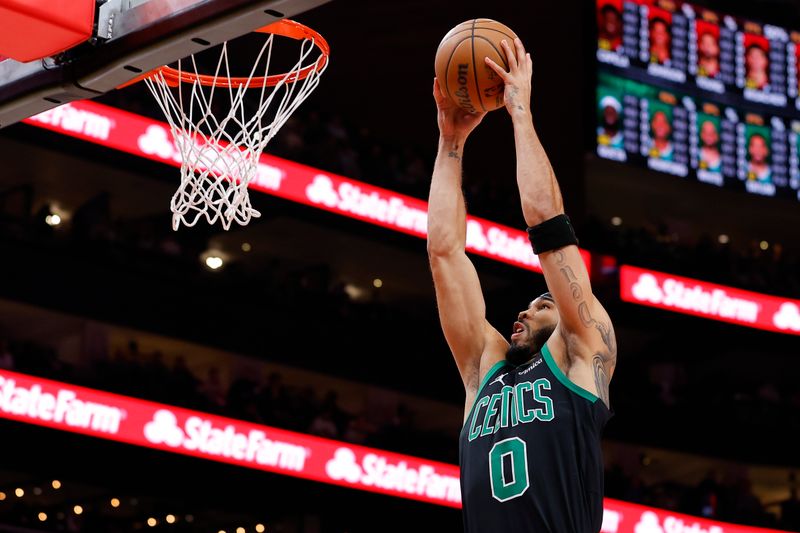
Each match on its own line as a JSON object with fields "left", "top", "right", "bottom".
{"left": 325, "top": 448, "right": 461, "bottom": 502}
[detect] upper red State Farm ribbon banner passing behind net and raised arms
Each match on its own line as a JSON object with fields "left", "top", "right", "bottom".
{"left": 24, "top": 101, "right": 590, "bottom": 272}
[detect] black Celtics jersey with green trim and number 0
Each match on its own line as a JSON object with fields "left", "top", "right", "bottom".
{"left": 459, "top": 345, "right": 611, "bottom": 533}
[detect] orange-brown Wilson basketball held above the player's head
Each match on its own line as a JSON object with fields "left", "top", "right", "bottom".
{"left": 435, "top": 19, "right": 517, "bottom": 113}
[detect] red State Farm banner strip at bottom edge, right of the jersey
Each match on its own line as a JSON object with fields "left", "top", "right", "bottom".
{"left": 600, "top": 498, "right": 777, "bottom": 533}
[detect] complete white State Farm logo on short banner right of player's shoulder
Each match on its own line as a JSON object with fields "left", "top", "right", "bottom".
{"left": 631, "top": 273, "right": 761, "bottom": 323}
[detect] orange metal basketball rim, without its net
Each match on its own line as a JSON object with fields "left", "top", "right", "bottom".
{"left": 130, "top": 19, "right": 330, "bottom": 88}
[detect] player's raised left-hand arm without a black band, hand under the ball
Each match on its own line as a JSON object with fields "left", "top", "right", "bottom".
{"left": 428, "top": 80, "right": 505, "bottom": 394}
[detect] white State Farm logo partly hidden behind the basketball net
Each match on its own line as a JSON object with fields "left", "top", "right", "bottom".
{"left": 136, "top": 124, "right": 286, "bottom": 191}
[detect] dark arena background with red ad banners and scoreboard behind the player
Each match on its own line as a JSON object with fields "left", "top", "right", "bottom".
{"left": 0, "top": 0, "right": 800, "bottom": 533}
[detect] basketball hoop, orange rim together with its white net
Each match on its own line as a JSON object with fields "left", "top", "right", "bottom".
{"left": 144, "top": 20, "right": 330, "bottom": 230}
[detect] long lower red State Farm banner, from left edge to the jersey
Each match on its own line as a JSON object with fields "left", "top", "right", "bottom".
{"left": 0, "top": 370, "right": 461, "bottom": 507}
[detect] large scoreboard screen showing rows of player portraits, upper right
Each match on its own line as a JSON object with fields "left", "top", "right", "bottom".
{"left": 596, "top": 0, "right": 800, "bottom": 200}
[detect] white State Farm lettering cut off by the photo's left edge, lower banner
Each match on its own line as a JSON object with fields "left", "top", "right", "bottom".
{"left": 0, "top": 376, "right": 125, "bottom": 434}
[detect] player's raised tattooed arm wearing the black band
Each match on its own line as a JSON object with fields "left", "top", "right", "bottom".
{"left": 486, "top": 39, "right": 617, "bottom": 404}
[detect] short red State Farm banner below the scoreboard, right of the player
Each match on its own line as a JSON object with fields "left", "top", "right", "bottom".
{"left": 620, "top": 266, "right": 800, "bottom": 335}
